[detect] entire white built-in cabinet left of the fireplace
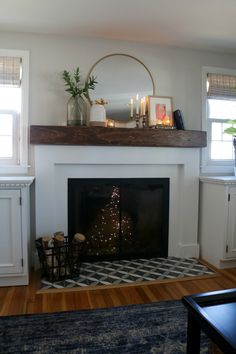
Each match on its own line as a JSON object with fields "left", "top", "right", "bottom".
{"left": 0, "top": 177, "right": 34, "bottom": 286}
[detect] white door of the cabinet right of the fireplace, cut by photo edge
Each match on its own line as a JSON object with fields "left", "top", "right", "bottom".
{"left": 226, "top": 187, "right": 236, "bottom": 258}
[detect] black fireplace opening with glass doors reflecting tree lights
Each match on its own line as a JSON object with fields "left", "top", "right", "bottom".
{"left": 68, "top": 178, "right": 169, "bottom": 261}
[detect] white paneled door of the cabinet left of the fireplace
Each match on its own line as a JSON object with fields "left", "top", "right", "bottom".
{"left": 0, "top": 190, "right": 23, "bottom": 276}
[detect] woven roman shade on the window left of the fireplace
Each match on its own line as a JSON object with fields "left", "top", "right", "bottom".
{"left": 0, "top": 56, "right": 22, "bottom": 87}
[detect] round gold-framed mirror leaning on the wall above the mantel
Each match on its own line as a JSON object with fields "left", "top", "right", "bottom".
{"left": 88, "top": 54, "right": 155, "bottom": 122}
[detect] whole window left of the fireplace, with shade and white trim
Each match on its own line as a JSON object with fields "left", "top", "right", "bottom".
{"left": 0, "top": 50, "right": 29, "bottom": 173}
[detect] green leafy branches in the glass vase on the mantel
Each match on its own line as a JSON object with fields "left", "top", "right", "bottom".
{"left": 62, "top": 67, "right": 97, "bottom": 98}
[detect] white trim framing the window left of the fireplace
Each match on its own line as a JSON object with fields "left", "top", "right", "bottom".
{"left": 0, "top": 49, "right": 30, "bottom": 175}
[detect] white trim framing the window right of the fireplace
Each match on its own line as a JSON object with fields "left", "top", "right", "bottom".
{"left": 200, "top": 66, "right": 236, "bottom": 175}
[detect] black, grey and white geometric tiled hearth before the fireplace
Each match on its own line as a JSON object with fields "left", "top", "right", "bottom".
{"left": 40, "top": 257, "right": 215, "bottom": 291}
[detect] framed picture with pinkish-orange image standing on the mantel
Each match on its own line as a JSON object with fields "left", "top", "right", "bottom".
{"left": 148, "top": 96, "right": 174, "bottom": 128}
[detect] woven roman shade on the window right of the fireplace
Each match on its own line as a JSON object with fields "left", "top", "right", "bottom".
{"left": 207, "top": 73, "right": 236, "bottom": 100}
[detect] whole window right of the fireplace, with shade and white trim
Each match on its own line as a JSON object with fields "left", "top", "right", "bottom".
{"left": 201, "top": 68, "right": 236, "bottom": 173}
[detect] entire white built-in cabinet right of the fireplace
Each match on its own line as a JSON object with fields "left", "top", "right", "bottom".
{"left": 199, "top": 176, "right": 236, "bottom": 268}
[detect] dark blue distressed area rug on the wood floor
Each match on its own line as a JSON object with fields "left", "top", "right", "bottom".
{"left": 0, "top": 301, "right": 209, "bottom": 354}
